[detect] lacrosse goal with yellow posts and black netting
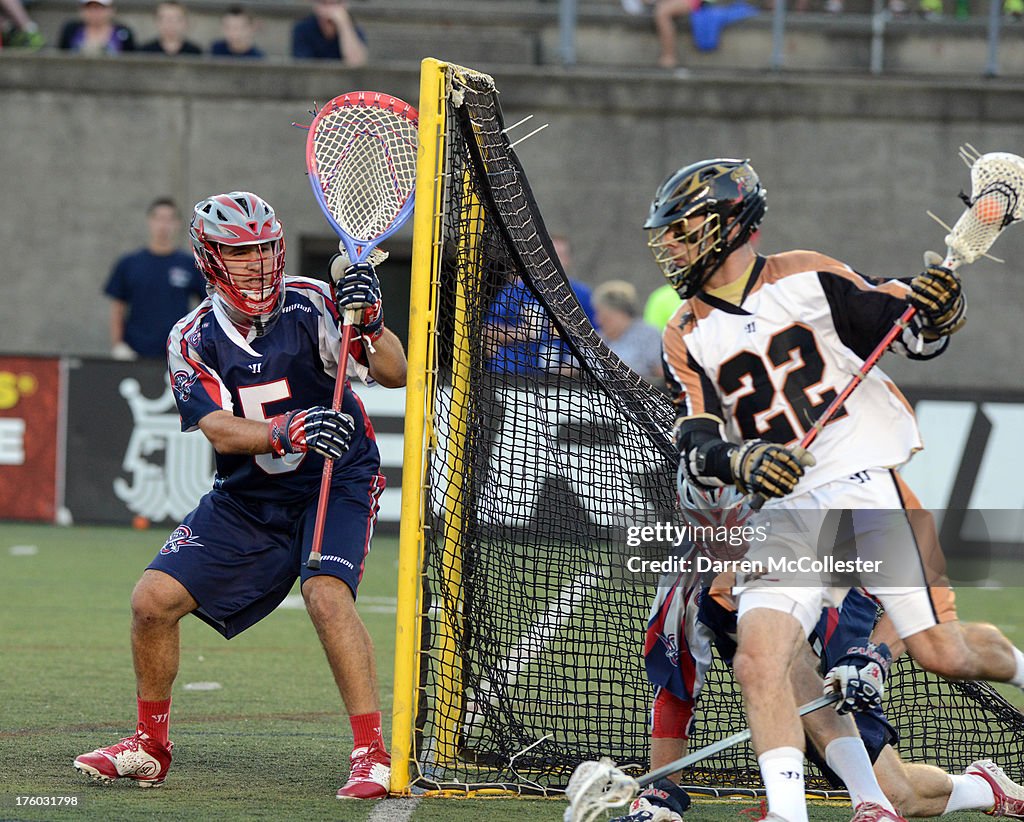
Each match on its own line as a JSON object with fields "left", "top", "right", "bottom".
{"left": 393, "top": 60, "right": 1024, "bottom": 793}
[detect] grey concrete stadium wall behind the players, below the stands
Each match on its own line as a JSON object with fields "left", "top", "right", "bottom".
{"left": 0, "top": 51, "right": 1024, "bottom": 388}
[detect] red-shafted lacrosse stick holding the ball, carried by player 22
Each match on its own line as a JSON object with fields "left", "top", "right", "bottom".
{"left": 751, "top": 144, "right": 1024, "bottom": 511}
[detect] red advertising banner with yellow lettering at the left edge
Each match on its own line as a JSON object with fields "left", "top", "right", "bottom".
{"left": 0, "top": 356, "right": 63, "bottom": 522}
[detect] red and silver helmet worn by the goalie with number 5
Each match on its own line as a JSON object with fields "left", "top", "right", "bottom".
{"left": 188, "top": 191, "right": 285, "bottom": 336}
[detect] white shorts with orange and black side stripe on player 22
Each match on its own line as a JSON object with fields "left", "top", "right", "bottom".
{"left": 734, "top": 469, "right": 956, "bottom": 638}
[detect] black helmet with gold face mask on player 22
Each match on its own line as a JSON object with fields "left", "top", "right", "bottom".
{"left": 643, "top": 159, "right": 768, "bottom": 299}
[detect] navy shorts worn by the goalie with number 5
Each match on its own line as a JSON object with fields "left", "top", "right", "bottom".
{"left": 147, "top": 472, "right": 384, "bottom": 639}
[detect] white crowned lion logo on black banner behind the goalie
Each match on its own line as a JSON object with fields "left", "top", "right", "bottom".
{"left": 114, "top": 379, "right": 213, "bottom": 522}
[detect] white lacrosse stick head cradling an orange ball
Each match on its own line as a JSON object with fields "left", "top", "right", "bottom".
{"left": 944, "top": 146, "right": 1024, "bottom": 269}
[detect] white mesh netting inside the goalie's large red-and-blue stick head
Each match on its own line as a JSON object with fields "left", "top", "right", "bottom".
{"left": 313, "top": 105, "right": 417, "bottom": 241}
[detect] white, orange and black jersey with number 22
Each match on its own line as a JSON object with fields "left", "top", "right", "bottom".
{"left": 663, "top": 251, "right": 929, "bottom": 490}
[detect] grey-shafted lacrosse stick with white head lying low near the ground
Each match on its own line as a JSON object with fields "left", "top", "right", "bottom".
{"left": 562, "top": 694, "right": 840, "bottom": 822}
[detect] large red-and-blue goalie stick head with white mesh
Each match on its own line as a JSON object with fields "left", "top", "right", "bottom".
{"left": 306, "top": 91, "right": 419, "bottom": 262}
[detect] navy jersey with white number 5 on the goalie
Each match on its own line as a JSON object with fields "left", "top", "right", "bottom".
{"left": 167, "top": 277, "right": 380, "bottom": 504}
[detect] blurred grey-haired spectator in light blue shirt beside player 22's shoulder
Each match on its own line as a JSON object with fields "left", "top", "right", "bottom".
{"left": 594, "top": 279, "right": 664, "bottom": 384}
